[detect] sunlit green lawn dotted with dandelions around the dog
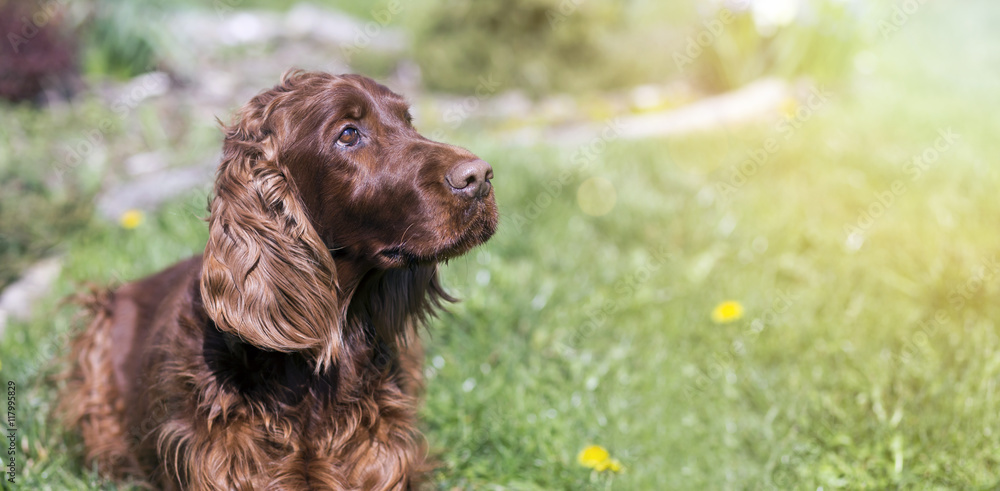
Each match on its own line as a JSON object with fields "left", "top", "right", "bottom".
{"left": 0, "top": 2, "right": 1000, "bottom": 490}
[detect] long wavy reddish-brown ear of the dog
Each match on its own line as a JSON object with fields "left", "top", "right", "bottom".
{"left": 201, "top": 89, "right": 342, "bottom": 370}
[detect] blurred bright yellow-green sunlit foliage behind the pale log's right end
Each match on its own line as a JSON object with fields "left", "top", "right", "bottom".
{"left": 692, "top": 0, "right": 864, "bottom": 91}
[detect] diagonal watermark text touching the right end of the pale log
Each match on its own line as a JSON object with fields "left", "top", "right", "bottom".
{"left": 715, "top": 86, "right": 833, "bottom": 198}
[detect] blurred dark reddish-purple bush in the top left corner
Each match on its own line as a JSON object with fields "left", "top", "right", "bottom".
{"left": 0, "top": 0, "right": 77, "bottom": 103}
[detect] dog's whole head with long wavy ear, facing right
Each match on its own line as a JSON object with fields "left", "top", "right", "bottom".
{"left": 201, "top": 72, "right": 497, "bottom": 366}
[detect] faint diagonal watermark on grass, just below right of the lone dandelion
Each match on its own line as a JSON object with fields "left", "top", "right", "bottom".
{"left": 684, "top": 289, "right": 798, "bottom": 400}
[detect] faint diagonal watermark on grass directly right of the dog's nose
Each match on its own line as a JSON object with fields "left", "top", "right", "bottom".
{"left": 509, "top": 118, "right": 623, "bottom": 232}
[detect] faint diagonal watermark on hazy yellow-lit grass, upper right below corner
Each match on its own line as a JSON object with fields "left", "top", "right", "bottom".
{"left": 844, "top": 128, "right": 961, "bottom": 250}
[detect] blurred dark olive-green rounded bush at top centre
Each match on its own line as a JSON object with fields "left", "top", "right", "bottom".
{"left": 412, "top": 0, "right": 622, "bottom": 95}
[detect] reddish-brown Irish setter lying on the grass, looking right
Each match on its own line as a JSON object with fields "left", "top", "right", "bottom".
{"left": 62, "top": 72, "right": 497, "bottom": 490}
